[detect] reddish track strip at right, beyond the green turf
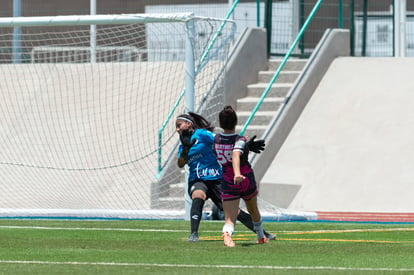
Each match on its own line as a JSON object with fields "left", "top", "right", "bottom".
{"left": 316, "top": 211, "right": 414, "bottom": 222}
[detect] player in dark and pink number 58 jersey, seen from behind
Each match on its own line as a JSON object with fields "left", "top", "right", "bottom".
{"left": 214, "top": 106, "right": 267, "bottom": 247}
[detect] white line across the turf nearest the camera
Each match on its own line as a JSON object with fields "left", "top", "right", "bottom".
{"left": 0, "top": 260, "right": 414, "bottom": 272}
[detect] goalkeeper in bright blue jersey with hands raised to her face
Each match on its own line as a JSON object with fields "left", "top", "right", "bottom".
{"left": 175, "top": 112, "right": 276, "bottom": 242}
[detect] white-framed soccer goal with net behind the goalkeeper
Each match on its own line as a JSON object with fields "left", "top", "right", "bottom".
{"left": 0, "top": 13, "right": 235, "bottom": 218}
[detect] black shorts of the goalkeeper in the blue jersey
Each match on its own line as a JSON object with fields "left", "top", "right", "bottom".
{"left": 187, "top": 179, "right": 223, "bottom": 210}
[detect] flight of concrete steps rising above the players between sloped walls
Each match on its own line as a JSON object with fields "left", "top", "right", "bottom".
{"left": 236, "top": 59, "right": 307, "bottom": 138}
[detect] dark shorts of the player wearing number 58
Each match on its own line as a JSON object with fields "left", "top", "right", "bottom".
{"left": 221, "top": 173, "right": 258, "bottom": 201}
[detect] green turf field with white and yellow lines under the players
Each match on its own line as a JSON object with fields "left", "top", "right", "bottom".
{"left": 0, "top": 219, "right": 414, "bottom": 274}
